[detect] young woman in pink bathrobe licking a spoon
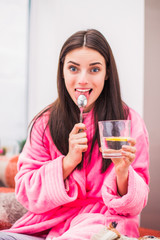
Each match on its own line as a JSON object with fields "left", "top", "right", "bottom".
{"left": 0, "top": 29, "right": 149, "bottom": 240}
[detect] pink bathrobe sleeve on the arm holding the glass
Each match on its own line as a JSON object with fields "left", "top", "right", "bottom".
{"left": 102, "top": 109, "right": 149, "bottom": 216}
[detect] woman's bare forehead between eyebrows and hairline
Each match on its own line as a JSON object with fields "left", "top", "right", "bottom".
{"left": 65, "top": 47, "right": 105, "bottom": 63}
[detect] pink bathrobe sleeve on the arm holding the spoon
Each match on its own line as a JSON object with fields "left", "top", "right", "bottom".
{"left": 15, "top": 116, "right": 78, "bottom": 214}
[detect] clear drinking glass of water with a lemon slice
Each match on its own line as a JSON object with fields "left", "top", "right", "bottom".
{"left": 98, "top": 120, "right": 131, "bottom": 158}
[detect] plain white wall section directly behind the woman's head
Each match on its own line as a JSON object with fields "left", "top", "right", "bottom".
{"left": 28, "top": 0, "right": 144, "bottom": 122}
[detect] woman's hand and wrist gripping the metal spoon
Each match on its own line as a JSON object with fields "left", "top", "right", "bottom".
{"left": 63, "top": 123, "right": 88, "bottom": 179}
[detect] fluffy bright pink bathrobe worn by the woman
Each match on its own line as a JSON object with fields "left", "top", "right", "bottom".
{"left": 7, "top": 109, "right": 149, "bottom": 240}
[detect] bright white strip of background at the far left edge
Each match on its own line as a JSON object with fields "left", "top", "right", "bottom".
{"left": 0, "top": 0, "right": 28, "bottom": 155}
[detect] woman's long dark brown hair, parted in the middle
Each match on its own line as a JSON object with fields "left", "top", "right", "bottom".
{"left": 31, "top": 29, "right": 129, "bottom": 173}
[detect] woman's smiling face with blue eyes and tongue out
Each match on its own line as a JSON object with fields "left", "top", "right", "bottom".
{"left": 63, "top": 47, "right": 106, "bottom": 112}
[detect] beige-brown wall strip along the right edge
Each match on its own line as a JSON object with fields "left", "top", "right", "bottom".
{"left": 141, "top": 0, "right": 160, "bottom": 230}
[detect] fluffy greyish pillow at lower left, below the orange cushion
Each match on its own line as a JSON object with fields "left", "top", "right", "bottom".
{"left": 0, "top": 192, "right": 27, "bottom": 230}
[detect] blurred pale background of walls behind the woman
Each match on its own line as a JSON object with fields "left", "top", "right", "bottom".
{"left": 0, "top": 0, "right": 160, "bottom": 230}
